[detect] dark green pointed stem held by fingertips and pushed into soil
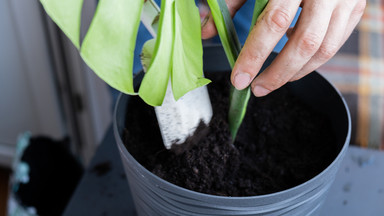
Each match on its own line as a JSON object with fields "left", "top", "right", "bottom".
{"left": 208, "top": 0, "right": 268, "bottom": 142}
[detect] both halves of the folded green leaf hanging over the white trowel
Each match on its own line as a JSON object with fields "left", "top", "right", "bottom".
{"left": 139, "top": 0, "right": 210, "bottom": 106}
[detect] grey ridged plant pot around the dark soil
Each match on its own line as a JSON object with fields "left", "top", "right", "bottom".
{"left": 114, "top": 47, "right": 351, "bottom": 216}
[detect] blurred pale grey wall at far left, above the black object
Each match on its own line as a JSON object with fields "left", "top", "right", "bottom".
{"left": 0, "top": 0, "right": 63, "bottom": 165}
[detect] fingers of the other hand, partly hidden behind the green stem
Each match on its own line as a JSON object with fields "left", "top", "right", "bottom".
{"left": 201, "top": 0, "right": 246, "bottom": 39}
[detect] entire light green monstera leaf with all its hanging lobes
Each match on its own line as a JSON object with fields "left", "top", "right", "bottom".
{"left": 40, "top": 0, "right": 210, "bottom": 106}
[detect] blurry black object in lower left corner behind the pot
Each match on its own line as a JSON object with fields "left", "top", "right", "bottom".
{"left": 14, "top": 136, "right": 83, "bottom": 216}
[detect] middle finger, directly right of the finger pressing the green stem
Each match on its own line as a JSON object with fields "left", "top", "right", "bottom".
{"left": 252, "top": 0, "right": 335, "bottom": 97}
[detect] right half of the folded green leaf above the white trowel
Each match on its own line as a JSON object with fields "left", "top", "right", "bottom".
{"left": 171, "top": 0, "right": 211, "bottom": 100}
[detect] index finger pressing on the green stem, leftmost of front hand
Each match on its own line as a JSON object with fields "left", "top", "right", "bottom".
{"left": 231, "top": 0, "right": 301, "bottom": 89}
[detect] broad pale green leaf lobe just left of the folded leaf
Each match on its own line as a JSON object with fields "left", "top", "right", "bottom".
{"left": 81, "top": 0, "right": 143, "bottom": 94}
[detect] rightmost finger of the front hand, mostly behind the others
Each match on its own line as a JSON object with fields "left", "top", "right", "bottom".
{"left": 290, "top": 0, "right": 365, "bottom": 81}
